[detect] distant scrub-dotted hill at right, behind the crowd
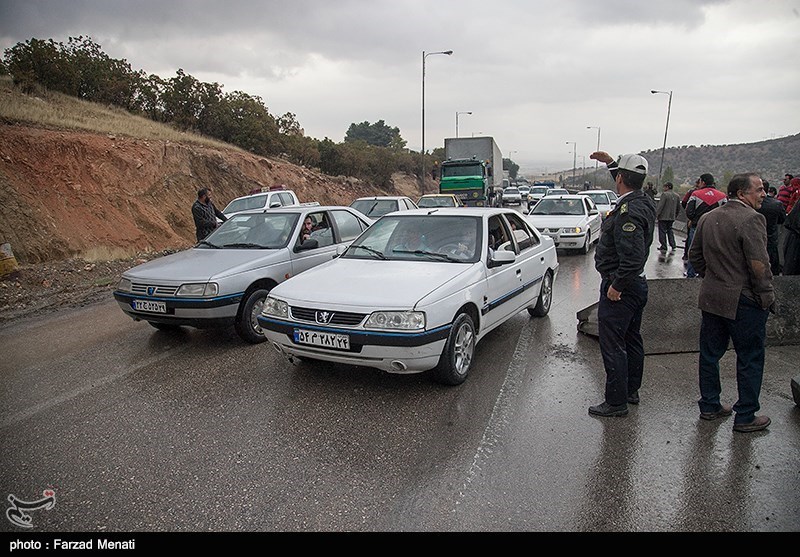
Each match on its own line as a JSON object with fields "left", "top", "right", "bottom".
{"left": 641, "top": 133, "right": 800, "bottom": 187}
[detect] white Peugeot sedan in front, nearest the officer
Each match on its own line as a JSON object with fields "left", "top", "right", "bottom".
{"left": 258, "top": 207, "right": 558, "bottom": 385}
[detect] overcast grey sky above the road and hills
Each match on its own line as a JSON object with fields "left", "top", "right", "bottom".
{"left": 0, "top": 0, "right": 800, "bottom": 172}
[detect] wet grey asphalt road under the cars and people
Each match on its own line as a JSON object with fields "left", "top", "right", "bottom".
{"left": 0, "top": 228, "right": 800, "bottom": 532}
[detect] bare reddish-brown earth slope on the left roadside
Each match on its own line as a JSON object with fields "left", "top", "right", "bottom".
{"left": 0, "top": 122, "right": 435, "bottom": 263}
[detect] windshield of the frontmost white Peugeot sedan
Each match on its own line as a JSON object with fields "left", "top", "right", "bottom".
{"left": 342, "top": 215, "right": 483, "bottom": 263}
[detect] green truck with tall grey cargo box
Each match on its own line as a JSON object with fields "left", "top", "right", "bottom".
{"left": 439, "top": 137, "right": 503, "bottom": 207}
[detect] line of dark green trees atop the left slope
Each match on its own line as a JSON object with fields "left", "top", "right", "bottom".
{"left": 0, "top": 36, "right": 432, "bottom": 188}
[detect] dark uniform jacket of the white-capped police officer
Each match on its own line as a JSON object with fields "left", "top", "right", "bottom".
{"left": 594, "top": 187, "right": 656, "bottom": 292}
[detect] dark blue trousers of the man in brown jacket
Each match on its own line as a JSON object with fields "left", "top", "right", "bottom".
{"left": 698, "top": 296, "right": 769, "bottom": 424}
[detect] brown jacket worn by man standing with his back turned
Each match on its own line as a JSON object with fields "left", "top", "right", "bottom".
{"left": 689, "top": 199, "right": 775, "bottom": 319}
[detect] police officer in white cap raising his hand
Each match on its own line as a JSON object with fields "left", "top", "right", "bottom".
{"left": 589, "top": 151, "right": 656, "bottom": 417}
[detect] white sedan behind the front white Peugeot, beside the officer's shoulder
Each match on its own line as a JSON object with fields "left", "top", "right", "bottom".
{"left": 528, "top": 194, "right": 602, "bottom": 253}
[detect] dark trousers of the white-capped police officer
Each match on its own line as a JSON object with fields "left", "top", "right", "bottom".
{"left": 597, "top": 278, "right": 647, "bottom": 406}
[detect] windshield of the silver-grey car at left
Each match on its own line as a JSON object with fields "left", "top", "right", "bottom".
{"left": 202, "top": 212, "right": 300, "bottom": 249}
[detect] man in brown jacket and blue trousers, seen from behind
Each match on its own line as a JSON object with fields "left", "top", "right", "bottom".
{"left": 689, "top": 173, "right": 775, "bottom": 433}
